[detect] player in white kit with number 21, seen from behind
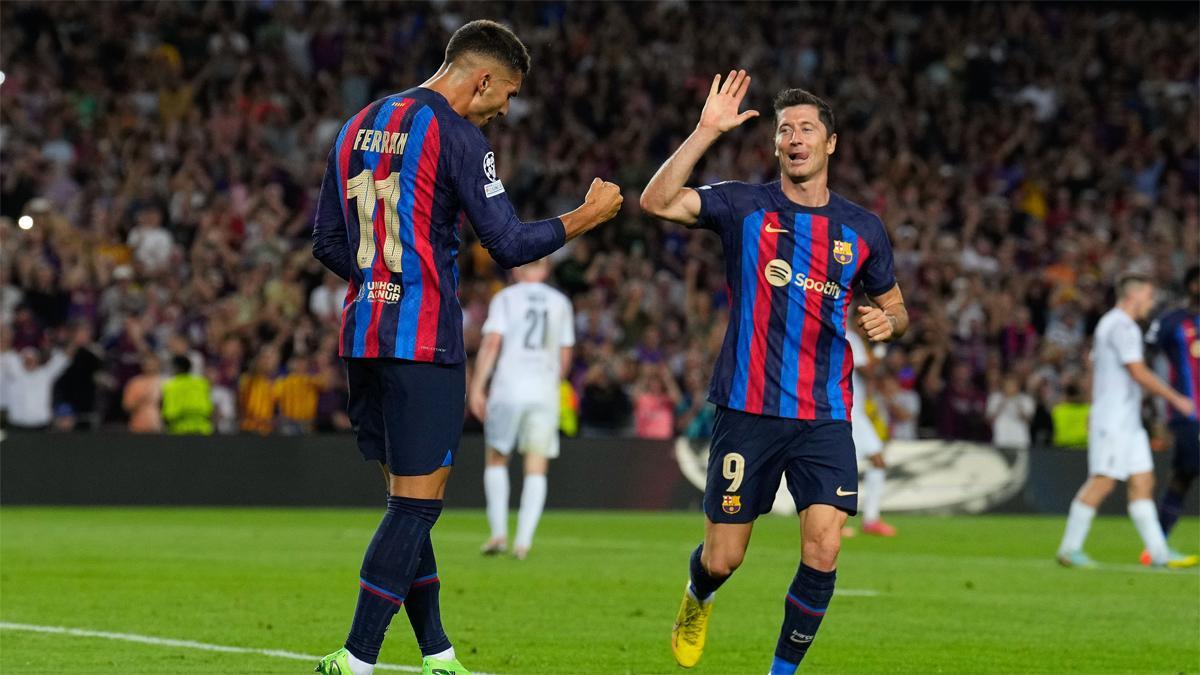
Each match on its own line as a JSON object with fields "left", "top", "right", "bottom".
{"left": 467, "top": 259, "right": 575, "bottom": 560}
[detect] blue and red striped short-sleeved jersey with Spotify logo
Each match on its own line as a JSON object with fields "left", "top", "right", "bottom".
{"left": 696, "top": 181, "right": 895, "bottom": 420}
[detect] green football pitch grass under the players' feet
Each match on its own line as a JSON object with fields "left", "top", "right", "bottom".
{"left": 0, "top": 507, "right": 1200, "bottom": 675}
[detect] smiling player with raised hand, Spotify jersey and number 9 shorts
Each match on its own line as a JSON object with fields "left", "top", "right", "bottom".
{"left": 641, "top": 71, "right": 908, "bottom": 675}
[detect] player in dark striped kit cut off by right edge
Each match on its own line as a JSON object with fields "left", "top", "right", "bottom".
{"left": 1142, "top": 265, "right": 1200, "bottom": 557}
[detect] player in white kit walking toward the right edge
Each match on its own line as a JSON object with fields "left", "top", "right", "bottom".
{"left": 1057, "top": 270, "right": 1200, "bottom": 568}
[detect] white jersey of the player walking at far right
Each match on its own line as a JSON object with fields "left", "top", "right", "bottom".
{"left": 1088, "top": 307, "right": 1144, "bottom": 430}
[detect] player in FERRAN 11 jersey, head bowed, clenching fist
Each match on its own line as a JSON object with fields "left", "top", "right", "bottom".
{"left": 313, "top": 20, "right": 622, "bottom": 675}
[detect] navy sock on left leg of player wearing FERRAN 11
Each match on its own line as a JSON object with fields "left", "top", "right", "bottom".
{"left": 346, "top": 497, "right": 442, "bottom": 663}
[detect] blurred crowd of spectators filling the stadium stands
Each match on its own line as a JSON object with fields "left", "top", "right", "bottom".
{"left": 0, "top": 1, "right": 1200, "bottom": 444}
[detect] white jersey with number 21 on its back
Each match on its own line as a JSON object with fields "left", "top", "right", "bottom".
{"left": 484, "top": 283, "right": 575, "bottom": 410}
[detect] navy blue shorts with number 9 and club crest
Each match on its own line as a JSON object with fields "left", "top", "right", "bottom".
{"left": 704, "top": 406, "right": 858, "bottom": 522}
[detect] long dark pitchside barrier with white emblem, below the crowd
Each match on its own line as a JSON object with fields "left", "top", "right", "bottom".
{"left": 0, "top": 432, "right": 1200, "bottom": 514}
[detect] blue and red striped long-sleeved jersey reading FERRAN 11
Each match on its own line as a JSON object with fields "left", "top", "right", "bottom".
{"left": 313, "top": 88, "right": 565, "bottom": 364}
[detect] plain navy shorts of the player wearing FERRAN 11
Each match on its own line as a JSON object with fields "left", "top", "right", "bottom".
{"left": 346, "top": 358, "right": 467, "bottom": 476}
